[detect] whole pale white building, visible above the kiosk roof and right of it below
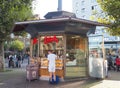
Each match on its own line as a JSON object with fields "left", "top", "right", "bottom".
{"left": 72, "top": 0, "right": 120, "bottom": 53}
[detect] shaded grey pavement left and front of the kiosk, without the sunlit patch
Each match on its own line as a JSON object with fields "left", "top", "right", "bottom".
{"left": 0, "top": 68, "right": 86, "bottom": 88}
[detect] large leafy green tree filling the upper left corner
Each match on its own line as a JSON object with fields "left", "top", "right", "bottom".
{"left": 0, "top": 0, "right": 33, "bottom": 70}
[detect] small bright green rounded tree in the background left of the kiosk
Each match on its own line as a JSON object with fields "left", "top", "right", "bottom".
{"left": 11, "top": 40, "right": 24, "bottom": 51}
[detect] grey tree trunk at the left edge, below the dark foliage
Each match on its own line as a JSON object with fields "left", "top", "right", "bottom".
{"left": 0, "top": 42, "right": 5, "bottom": 70}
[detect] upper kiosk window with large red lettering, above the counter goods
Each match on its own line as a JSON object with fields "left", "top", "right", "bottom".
{"left": 40, "top": 36, "right": 64, "bottom": 57}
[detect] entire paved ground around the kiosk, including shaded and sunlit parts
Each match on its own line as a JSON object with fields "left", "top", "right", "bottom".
{"left": 0, "top": 68, "right": 120, "bottom": 88}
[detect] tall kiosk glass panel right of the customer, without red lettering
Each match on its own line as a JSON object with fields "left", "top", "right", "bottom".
{"left": 66, "top": 35, "right": 86, "bottom": 77}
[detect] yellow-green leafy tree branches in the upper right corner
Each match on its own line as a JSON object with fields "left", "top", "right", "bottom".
{"left": 97, "top": 0, "right": 120, "bottom": 35}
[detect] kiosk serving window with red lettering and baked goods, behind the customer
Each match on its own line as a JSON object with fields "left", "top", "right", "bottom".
{"left": 40, "top": 35, "right": 64, "bottom": 69}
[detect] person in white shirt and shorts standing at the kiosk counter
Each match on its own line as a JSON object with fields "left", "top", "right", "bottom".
{"left": 48, "top": 50, "right": 57, "bottom": 81}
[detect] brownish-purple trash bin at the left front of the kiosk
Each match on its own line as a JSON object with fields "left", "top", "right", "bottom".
{"left": 26, "top": 64, "right": 39, "bottom": 81}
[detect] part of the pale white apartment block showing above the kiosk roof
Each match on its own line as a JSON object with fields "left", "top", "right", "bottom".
{"left": 73, "top": 0, "right": 101, "bottom": 20}
